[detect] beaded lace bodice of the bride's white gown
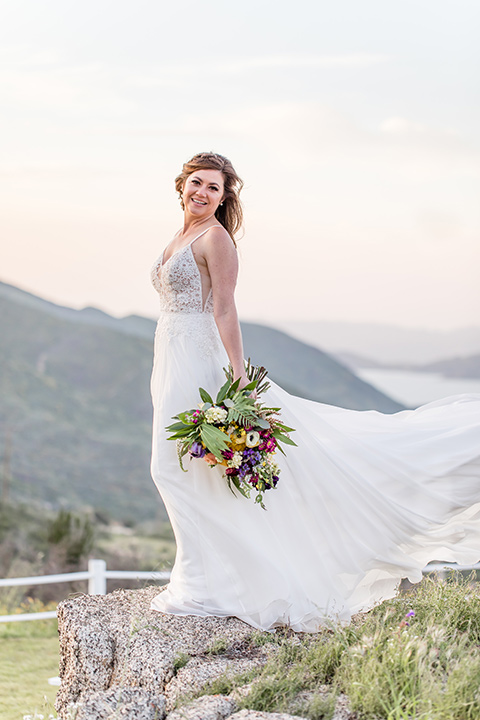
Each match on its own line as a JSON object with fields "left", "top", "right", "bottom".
{"left": 152, "top": 228, "right": 221, "bottom": 356}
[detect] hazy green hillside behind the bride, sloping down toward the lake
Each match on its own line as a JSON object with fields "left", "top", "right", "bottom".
{"left": 0, "top": 284, "right": 401, "bottom": 520}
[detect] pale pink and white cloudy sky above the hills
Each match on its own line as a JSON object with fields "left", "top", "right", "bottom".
{"left": 0, "top": 0, "right": 480, "bottom": 330}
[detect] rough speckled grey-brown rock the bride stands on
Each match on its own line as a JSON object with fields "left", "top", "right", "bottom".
{"left": 55, "top": 587, "right": 354, "bottom": 720}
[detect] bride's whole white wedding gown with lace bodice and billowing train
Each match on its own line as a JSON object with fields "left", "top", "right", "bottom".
{"left": 152, "top": 233, "right": 480, "bottom": 632}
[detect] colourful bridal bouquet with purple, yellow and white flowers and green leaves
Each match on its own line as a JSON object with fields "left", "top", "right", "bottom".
{"left": 167, "top": 360, "right": 296, "bottom": 509}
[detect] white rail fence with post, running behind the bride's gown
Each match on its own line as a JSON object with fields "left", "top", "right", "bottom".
{"left": 0, "top": 560, "right": 480, "bottom": 623}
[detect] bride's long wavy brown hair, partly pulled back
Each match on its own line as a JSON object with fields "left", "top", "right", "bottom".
{"left": 175, "top": 153, "right": 243, "bottom": 245}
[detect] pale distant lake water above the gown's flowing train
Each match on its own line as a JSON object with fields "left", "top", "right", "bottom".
{"left": 355, "top": 368, "right": 480, "bottom": 407}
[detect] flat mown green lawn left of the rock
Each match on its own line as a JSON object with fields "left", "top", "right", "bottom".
{"left": 0, "top": 602, "right": 59, "bottom": 720}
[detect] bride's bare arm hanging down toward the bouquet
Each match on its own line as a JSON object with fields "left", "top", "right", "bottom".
{"left": 204, "top": 228, "right": 250, "bottom": 388}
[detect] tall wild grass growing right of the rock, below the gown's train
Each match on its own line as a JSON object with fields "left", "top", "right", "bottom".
{"left": 196, "top": 574, "right": 480, "bottom": 720}
